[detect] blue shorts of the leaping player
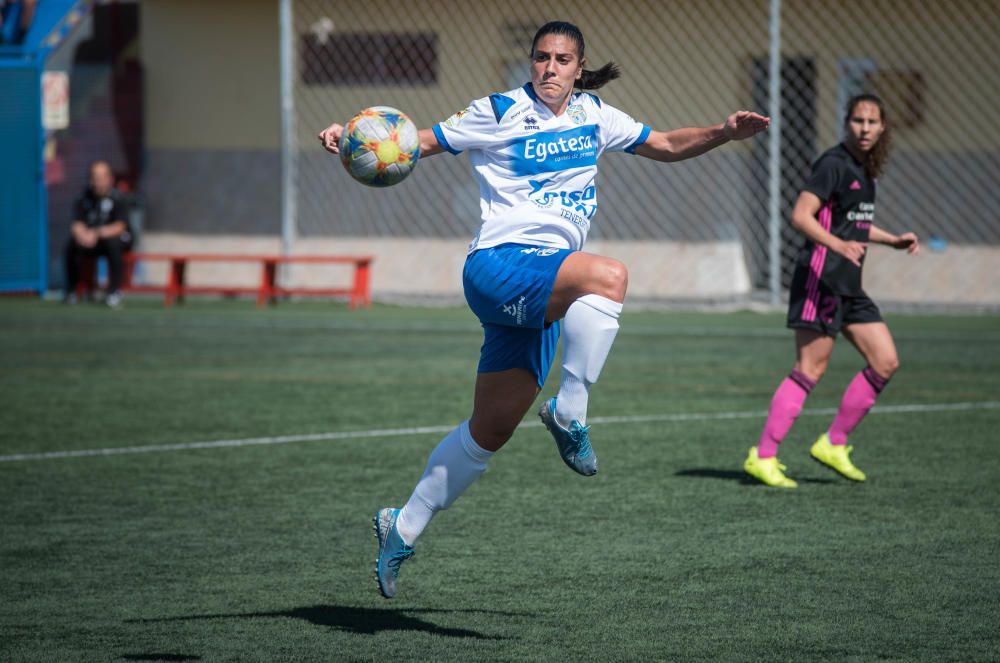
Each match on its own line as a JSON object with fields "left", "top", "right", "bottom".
{"left": 462, "top": 244, "right": 573, "bottom": 387}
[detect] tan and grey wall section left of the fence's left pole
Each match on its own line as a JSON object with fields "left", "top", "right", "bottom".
{"left": 141, "top": 0, "right": 281, "bottom": 234}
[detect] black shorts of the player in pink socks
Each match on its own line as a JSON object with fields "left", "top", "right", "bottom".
{"left": 788, "top": 269, "right": 882, "bottom": 336}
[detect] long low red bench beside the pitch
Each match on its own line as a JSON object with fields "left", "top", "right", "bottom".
{"left": 122, "top": 252, "right": 374, "bottom": 308}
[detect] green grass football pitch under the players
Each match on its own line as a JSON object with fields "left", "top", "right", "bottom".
{"left": 0, "top": 299, "right": 1000, "bottom": 662}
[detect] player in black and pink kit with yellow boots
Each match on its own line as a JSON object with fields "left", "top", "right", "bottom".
{"left": 743, "top": 94, "right": 920, "bottom": 488}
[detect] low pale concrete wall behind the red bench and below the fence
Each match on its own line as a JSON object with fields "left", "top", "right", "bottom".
{"left": 133, "top": 233, "right": 1000, "bottom": 307}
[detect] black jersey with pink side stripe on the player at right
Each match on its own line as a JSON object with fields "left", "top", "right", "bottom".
{"left": 797, "top": 143, "right": 875, "bottom": 295}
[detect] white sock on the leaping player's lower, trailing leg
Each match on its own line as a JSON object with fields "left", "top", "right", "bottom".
{"left": 396, "top": 420, "right": 493, "bottom": 546}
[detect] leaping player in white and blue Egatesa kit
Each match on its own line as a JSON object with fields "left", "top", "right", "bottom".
{"left": 319, "top": 21, "right": 770, "bottom": 598}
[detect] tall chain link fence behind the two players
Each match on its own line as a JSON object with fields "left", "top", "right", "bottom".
{"left": 292, "top": 0, "right": 1000, "bottom": 300}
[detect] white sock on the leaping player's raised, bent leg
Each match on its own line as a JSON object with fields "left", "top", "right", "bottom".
{"left": 556, "top": 295, "right": 622, "bottom": 427}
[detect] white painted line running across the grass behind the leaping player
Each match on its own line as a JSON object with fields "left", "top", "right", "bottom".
{"left": 0, "top": 401, "right": 1000, "bottom": 463}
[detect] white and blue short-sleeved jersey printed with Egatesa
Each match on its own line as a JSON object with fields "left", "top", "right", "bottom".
{"left": 433, "top": 83, "right": 650, "bottom": 252}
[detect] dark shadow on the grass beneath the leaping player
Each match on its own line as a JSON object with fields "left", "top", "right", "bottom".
{"left": 125, "top": 605, "right": 522, "bottom": 640}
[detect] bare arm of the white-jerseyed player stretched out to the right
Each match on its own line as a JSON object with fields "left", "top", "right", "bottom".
{"left": 635, "top": 111, "right": 771, "bottom": 161}
